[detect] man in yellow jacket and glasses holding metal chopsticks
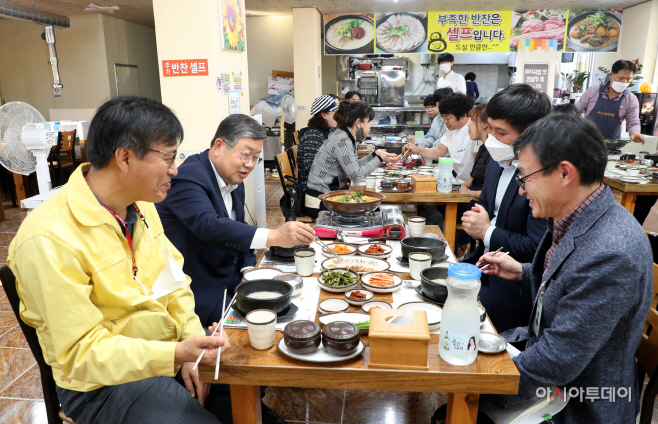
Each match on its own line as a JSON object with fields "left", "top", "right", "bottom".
{"left": 7, "top": 96, "right": 230, "bottom": 424}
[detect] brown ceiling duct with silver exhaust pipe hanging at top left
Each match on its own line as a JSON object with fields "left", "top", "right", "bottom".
{"left": 0, "top": 0, "right": 71, "bottom": 90}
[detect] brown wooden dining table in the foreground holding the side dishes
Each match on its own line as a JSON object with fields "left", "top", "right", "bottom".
{"left": 199, "top": 226, "right": 519, "bottom": 424}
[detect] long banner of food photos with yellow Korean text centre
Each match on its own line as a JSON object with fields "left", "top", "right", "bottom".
{"left": 324, "top": 9, "right": 623, "bottom": 55}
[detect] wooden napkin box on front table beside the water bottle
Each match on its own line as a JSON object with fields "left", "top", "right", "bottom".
{"left": 368, "top": 309, "right": 430, "bottom": 371}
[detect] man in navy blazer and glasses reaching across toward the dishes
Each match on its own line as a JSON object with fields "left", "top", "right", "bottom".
{"left": 156, "top": 114, "right": 313, "bottom": 326}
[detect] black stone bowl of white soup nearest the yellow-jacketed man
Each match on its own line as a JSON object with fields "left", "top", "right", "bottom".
{"left": 235, "top": 280, "right": 292, "bottom": 315}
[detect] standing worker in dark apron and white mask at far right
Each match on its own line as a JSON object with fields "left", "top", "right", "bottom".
{"left": 576, "top": 60, "right": 645, "bottom": 144}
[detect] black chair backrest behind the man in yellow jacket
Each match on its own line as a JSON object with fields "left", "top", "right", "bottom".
{"left": 0, "top": 265, "right": 62, "bottom": 424}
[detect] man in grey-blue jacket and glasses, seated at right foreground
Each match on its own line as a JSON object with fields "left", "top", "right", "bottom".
{"left": 472, "top": 114, "right": 653, "bottom": 424}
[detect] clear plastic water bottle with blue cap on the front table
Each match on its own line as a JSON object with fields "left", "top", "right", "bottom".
{"left": 439, "top": 263, "right": 482, "bottom": 365}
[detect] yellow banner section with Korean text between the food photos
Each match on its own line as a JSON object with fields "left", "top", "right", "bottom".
{"left": 427, "top": 11, "right": 512, "bottom": 53}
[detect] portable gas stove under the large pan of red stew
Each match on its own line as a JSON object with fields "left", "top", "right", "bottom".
{"left": 315, "top": 205, "right": 405, "bottom": 240}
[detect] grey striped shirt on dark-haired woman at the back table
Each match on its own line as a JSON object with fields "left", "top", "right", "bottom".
{"left": 307, "top": 128, "right": 381, "bottom": 193}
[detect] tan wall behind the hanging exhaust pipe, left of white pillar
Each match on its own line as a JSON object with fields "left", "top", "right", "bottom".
{"left": 0, "top": 15, "right": 160, "bottom": 120}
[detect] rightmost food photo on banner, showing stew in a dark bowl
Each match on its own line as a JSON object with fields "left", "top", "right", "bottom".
{"left": 565, "top": 9, "right": 623, "bottom": 52}
